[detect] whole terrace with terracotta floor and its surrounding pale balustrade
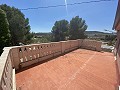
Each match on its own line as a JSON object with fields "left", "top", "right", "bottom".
{"left": 0, "top": 39, "right": 119, "bottom": 90}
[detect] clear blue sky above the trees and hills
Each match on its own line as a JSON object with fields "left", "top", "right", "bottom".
{"left": 0, "top": 0, "right": 118, "bottom": 32}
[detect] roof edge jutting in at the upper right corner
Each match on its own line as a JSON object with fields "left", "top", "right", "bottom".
{"left": 113, "top": 0, "right": 120, "bottom": 30}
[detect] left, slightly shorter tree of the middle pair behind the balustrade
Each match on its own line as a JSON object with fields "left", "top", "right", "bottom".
{"left": 52, "top": 20, "right": 69, "bottom": 41}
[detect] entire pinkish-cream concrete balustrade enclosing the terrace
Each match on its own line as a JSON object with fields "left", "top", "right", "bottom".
{"left": 0, "top": 39, "right": 102, "bottom": 90}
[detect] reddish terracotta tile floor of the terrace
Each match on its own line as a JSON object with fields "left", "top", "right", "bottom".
{"left": 16, "top": 49, "right": 118, "bottom": 90}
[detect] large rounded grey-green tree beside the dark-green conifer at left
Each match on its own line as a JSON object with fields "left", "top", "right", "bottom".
{"left": 0, "top": 4, "right": 32, "bottom": 45}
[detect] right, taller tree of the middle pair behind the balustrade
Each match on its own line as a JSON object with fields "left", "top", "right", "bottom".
{"left": 69, "top": 16, "right": 87, "bottom": 40}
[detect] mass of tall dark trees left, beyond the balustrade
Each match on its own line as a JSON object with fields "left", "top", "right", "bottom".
{"left": 0, "top": 4, "right": 33, "bottom": 53}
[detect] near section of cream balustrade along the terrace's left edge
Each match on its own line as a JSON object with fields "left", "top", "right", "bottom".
{"left": 0, "top": 48, "right": 15, "bottom": 90}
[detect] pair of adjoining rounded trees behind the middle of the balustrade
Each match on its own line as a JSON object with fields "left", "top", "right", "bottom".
{"left": 52, "top": 16, "right": 87, "bottom": 41}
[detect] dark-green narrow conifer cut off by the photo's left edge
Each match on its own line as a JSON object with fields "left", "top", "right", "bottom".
{"left": 0, "top": 9, "right": 10, "bottom": 54}
